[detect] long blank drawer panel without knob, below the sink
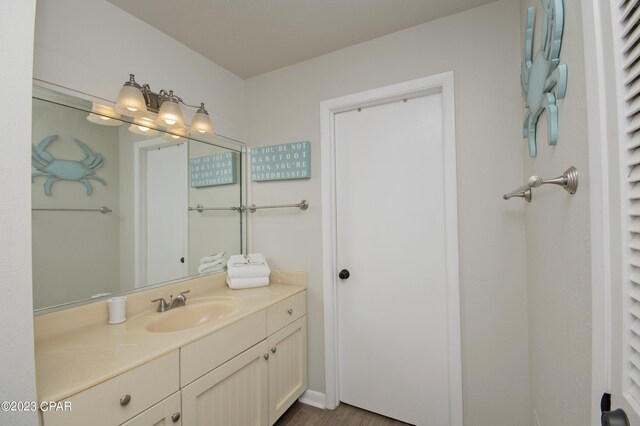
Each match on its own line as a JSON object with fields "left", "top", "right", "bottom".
{"left": 180, "top": 310, "right": 267, "bottom": 386}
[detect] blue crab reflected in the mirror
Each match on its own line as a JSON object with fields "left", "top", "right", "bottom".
{"left": 31, "top": 135, "right": 107, "bottom": 195}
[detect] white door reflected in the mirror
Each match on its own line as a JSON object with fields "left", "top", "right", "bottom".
{"left": 145, "top": 144, "right": 189, "bottom": 284}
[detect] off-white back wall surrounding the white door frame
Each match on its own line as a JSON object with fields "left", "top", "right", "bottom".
{"left": 247, "top": 0, "right": 529, "bottom": 426}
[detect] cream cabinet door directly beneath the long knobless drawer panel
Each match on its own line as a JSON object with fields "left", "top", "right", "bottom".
{"left": 182, "top": 340, "right": 270, "bottom": 426}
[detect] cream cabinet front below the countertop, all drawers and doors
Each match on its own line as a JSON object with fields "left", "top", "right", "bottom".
{"left": 42, "top": 290, "right": 307, "bottom": 426}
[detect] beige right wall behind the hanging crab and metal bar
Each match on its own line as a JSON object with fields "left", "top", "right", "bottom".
{"left": 520, "top": 0, "right": 591, "bottom": 426}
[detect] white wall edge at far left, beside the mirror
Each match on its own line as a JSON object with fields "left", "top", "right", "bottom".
{"left": 0, "top": 0, "right": 37, "bottom": 426}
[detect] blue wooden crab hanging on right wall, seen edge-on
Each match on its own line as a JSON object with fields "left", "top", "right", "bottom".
{"left": 520, "top": 0, "right": 567, "bottom": 157}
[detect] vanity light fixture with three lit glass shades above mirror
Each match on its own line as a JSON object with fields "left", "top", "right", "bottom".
{"left": 116, "top": 74, "right": 213, "bottom": 136}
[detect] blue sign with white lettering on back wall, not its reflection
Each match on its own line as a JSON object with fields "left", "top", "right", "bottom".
{"left": 251, "top": 141, "right": 311, "bottom": 182}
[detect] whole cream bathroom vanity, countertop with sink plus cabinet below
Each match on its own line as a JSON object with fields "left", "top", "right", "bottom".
{"left": 35, "top": 271, "right": 307, "bottom": 426}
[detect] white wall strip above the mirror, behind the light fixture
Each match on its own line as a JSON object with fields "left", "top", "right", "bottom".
{"left": 33, "top": 0, "right": 245, "bottom": 140}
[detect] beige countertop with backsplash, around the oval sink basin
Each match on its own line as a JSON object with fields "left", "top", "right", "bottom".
{"left": 34, "top": 271, "right": 306, "bottom": 401}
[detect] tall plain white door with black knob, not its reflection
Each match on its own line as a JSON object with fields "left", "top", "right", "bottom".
{"left": 335, "top": 93, "right": 449, "bottom": 426}
